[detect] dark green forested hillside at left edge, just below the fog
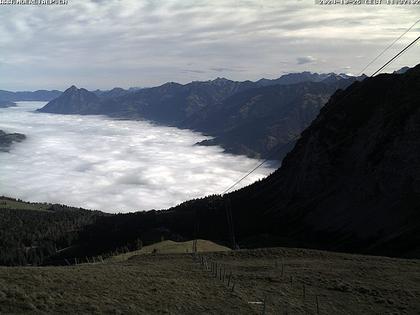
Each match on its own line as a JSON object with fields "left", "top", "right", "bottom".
{"left": 0, "top": 197, "right": 104, "bottom": 266}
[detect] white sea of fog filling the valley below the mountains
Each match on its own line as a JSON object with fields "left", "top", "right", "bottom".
{"left": 0, "top": 102, "right": 274, "bottom": 212}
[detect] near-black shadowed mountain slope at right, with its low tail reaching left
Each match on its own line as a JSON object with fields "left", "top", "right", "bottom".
{"left": 74, "top": 65, "right": 420, "bottom": 257}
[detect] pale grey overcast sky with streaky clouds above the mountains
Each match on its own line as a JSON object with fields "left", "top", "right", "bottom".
{"left": 0, "top": 0, "right": 420, "bottom": 90}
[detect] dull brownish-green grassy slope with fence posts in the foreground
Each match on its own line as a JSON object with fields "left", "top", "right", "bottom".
{"left": 0, "top": 248, "right": 420, "bottom": 314}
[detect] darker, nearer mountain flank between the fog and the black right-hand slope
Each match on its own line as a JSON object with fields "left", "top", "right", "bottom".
{"left": 182, "top": 79, "right": 355, "bottom": 160}
